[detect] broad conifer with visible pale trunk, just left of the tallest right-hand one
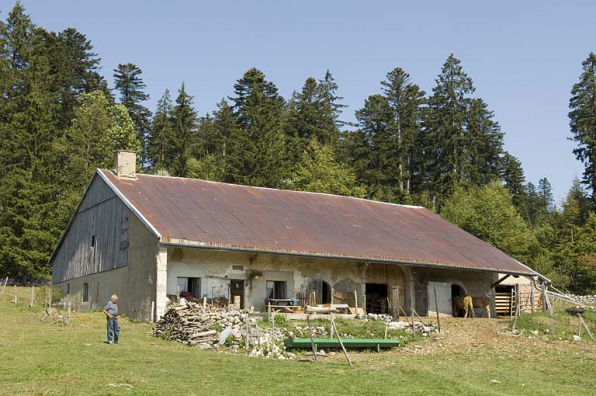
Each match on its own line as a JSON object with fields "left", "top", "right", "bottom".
{"left": 348, "top": 68, "right": 424, "bottom": 202}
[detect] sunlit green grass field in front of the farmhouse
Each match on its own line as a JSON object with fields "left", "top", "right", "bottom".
{"left": 0, "top": 290, "right": 596, "bottom": 396}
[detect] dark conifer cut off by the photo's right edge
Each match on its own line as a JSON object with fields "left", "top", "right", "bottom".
{"left": 569, "top": 52, "right": 596, "bottom": 203}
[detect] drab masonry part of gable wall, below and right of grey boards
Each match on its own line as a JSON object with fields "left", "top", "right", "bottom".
{"left": 54, "top": 206, "right": 158, "bottom": 320}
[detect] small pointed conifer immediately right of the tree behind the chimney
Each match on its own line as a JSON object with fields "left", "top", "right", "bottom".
{"left": 148, "top": 89, "right": 175, "bottom": 170}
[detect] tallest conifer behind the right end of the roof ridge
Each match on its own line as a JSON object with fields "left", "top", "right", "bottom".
{"left": 425, "top": 55, "right": 503, "bottom": 204}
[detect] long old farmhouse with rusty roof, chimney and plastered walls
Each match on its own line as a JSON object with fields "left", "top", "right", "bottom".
{"left": 51, "top": 151, "right": 546, "bottom": 320}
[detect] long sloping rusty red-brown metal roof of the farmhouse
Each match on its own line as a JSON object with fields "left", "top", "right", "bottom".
{"left": 98, "top": 170, "right": 536, "bottom": 275}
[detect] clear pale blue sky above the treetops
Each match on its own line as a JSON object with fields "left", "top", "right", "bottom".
{"left": 0, "top": 0, "right": 596, "bottom": 199}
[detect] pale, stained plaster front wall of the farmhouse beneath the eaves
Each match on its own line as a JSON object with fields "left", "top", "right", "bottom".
{"left": 167, "top": 247, "right": 416, "bottom": 310}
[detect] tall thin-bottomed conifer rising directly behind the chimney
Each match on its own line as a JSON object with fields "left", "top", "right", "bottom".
{"left": 114, "top": 63, "right": 151, "bottom": 165}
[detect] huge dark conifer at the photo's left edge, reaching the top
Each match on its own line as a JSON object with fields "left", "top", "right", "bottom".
{"left": 0, "top": 2, "right": 62, "bottom": 280}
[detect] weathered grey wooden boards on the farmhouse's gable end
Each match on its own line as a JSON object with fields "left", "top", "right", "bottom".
{"left": 53, "top": 176, "right": 131, "bottom": 283}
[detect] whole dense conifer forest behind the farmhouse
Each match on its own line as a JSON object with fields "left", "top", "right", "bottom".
{"left": 0, "top": 2, "right": 596, "bottom": 294}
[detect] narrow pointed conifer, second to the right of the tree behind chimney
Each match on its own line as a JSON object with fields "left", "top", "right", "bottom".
{"left": 170, "top": 83, "right": 197, "bottom": 177}
